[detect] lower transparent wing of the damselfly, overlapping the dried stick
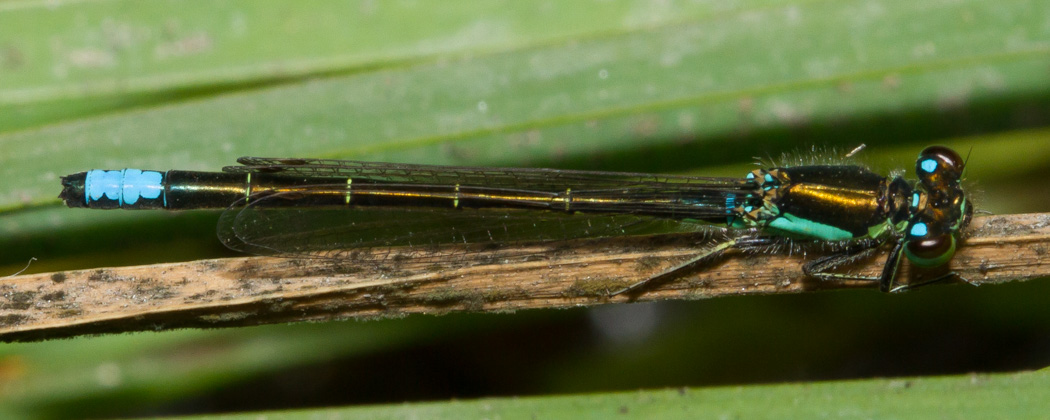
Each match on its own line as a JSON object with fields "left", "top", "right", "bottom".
{"left": 218, "top": 185, "right": 719, "bottom": 261}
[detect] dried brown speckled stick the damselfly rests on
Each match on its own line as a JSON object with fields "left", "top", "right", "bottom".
{"left": 0, "top": 213, "right": 1050, "bottom": 341}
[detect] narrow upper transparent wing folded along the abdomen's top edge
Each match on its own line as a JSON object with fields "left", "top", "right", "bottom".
{"left": 223, "top": 158, "right": 750, "bottom": 191}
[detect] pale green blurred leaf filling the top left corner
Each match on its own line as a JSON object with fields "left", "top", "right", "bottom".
{"left": 0, "top": 0, "right": 781, "bottom": 130}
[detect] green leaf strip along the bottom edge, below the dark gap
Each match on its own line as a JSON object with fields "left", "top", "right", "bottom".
{"left": 184, "top": 371, "right": 1050, "bottom": 420}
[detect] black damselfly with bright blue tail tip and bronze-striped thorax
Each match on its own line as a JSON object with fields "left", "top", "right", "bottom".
{"left": 60, "top": 146, "right": 973, "bottom": 294}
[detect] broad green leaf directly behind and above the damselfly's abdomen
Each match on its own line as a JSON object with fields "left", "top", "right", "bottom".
{"left": 0, "top": 1, "right": 1050, "bottom": 208}
